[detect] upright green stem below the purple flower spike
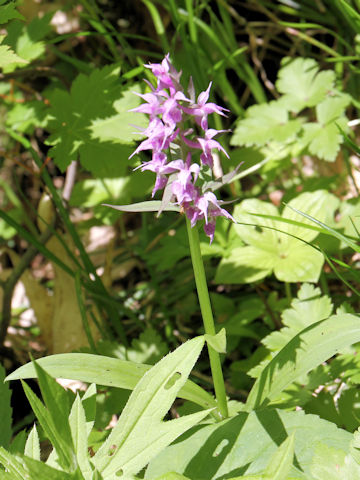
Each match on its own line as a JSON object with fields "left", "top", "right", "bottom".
{"left": 186, "top": 219, "right": 229, "bottom": 418}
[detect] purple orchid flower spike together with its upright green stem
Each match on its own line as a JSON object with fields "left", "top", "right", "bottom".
{"left": 116, "top": 54, "right": 235, "bottom": 418}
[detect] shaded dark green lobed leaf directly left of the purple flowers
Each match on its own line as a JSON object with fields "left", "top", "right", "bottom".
{"left": 47, "top": 70, "right": 145, "bottom": 178}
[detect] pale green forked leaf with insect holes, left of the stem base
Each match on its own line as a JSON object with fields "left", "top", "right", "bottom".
{"left": 92, "top": 337, "right": 209, "bottom": 477}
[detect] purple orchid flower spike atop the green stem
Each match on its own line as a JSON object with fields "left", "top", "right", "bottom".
{"left": 131, "top": 54, "right": 234, "bottom": 243}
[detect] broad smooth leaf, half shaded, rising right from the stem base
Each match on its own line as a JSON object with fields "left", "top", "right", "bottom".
{"left": 246, "top": 313, "right": 360, "bottom": 409}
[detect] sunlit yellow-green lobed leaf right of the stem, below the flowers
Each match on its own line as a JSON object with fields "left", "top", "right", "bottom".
{"left": 215, "top": 190, "right": 339, "bottom": 284}
